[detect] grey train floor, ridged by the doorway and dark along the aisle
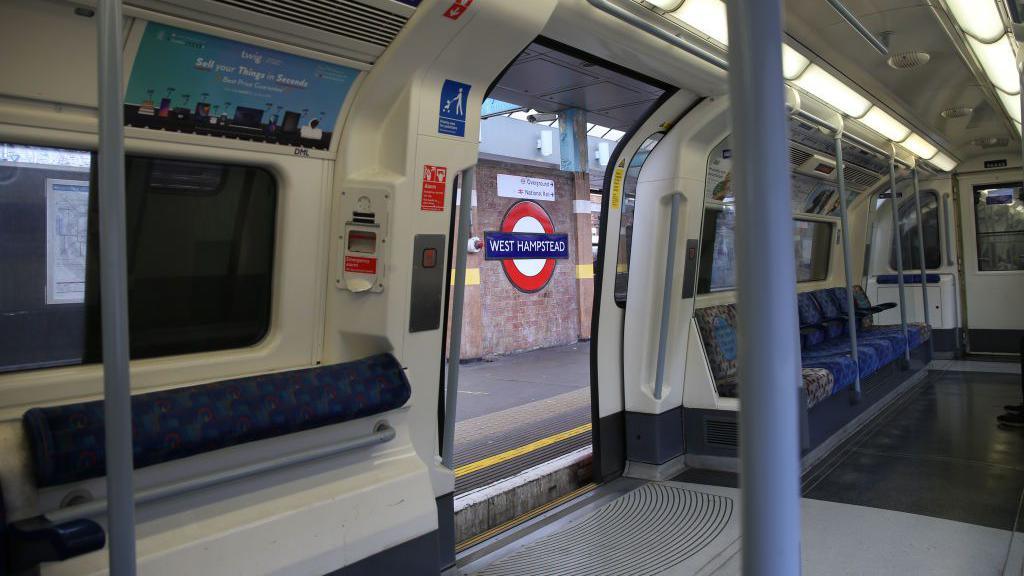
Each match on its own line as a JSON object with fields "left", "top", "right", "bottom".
{"left": 459, "top": 361, "right": 1024, "bottom": 576}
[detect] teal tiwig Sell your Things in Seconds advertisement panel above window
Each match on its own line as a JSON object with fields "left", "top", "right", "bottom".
{"left": 125, "top": 23, "right": 359, "bottom": 150}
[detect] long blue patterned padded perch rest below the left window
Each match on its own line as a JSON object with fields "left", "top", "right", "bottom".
{"left": 23, "top": 354, "right": 412, "bottom": 487}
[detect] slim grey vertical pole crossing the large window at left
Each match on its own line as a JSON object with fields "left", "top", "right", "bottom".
{"left": 96, "top": 0, "right": 135, "bottom": 576}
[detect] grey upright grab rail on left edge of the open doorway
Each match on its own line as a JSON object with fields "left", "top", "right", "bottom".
{"left": 441, "top": 166, "right": 476, "bottom": 469}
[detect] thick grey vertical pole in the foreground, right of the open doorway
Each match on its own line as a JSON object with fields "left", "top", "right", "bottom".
{"left": 726, "top": 0, "right": 801, "bottom": 576}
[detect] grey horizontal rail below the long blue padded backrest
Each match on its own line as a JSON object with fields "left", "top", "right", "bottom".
{"left": 43, "top": 422, "right": 395, "bottom": 524}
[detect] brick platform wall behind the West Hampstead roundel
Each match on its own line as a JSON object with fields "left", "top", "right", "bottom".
{"left": 466, "top": 160, "right": 590, "bottom": 357}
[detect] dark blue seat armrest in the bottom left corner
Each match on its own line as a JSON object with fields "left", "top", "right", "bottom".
{"left": 4, "top": 516, "right": 106, "bottom": 574}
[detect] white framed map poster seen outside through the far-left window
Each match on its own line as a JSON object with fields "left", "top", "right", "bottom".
{"left": 46, "top": 178, "right": 89, "bottom": 304}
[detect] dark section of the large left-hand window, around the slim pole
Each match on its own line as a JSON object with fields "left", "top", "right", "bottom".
{"left": 87, "top": 157, "right": 278, "bottom": 361}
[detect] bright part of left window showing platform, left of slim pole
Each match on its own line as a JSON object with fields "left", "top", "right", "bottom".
{"left": 0, "top": 143, "right": 92, "bottom": 372}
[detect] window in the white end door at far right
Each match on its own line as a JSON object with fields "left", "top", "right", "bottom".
{"left": 974, "top": 184, "right": 1024, "bottom": 272}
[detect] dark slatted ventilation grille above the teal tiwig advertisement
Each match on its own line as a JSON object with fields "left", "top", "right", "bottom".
{"left": 210, "top": 0, "right": 408, "bottom": 47}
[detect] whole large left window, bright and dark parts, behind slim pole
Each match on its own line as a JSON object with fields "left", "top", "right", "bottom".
{"left": 0, "top": 143, "right": 276, "bottom": 372}
